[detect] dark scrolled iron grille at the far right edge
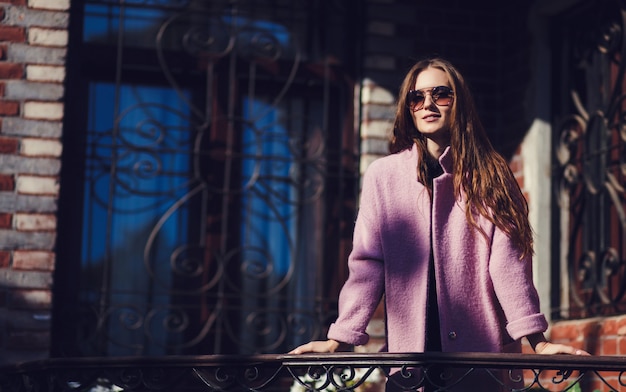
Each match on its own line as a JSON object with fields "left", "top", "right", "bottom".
{"left": 555, "top": 1, "right": 626, "bottom": 318}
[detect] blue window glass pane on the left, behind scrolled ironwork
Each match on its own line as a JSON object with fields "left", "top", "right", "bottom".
{"left": 81, "top": 83, "right": 192, "bottom": 355}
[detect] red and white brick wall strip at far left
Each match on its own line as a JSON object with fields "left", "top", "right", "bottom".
{"left": 0, "top": 0, "right": 69, "bottom": 364}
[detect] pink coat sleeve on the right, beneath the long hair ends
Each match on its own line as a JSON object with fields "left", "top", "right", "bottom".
{"left": 489, "top": 228, "right": 548, "bottom": 340}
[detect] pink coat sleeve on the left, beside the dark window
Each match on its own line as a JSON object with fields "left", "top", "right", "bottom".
{"left": 328, "top": 167, "right": 384, "bottom": 345}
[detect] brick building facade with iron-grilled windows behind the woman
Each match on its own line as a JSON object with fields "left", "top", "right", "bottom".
{"left": 0, "top": 0, "right": 626, "bottom": 363}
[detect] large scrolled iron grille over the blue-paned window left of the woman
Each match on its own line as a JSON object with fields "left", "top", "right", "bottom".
{"left": 70, "top": 0, "right": 358, "bottom": 355}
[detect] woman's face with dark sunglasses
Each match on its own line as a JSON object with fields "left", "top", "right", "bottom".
{"left": 411, "top": 68, "right": 454, "bottom": 147}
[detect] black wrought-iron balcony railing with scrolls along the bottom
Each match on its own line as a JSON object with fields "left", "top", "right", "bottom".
{"left": 0, "top": 353, "right": 626, "bottom": 392}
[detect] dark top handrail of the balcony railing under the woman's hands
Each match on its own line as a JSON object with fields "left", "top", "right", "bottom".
{"left": 0, "top": 352, "right": 626, "bottom": 374}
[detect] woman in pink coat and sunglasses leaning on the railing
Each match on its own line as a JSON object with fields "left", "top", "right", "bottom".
{"left": 291, "top": 58, "right": 587, "bottom": 390}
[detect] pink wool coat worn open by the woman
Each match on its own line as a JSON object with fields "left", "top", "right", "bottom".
{"left": 328, "top": 146, "right": 548, "bottom": 352}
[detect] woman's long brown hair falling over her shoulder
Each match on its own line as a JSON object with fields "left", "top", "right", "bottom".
{"left": 390, "top": 58, "right": 533, "bottom": 258}
